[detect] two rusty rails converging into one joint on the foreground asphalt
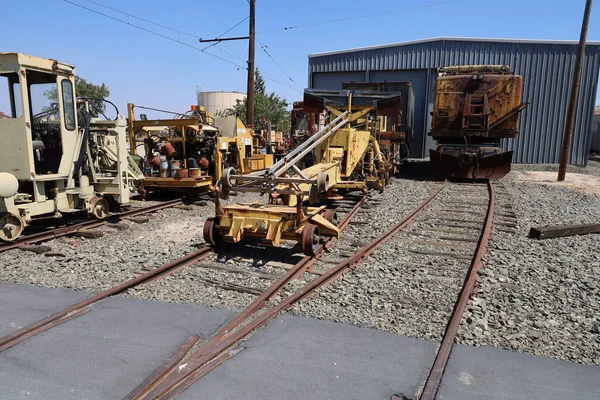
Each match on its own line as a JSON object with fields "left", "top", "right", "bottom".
{"left": 126, "top": 183, "right": 445, "bottom": 400}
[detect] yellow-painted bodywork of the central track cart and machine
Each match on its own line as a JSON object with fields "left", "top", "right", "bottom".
{"left": 211, "top": 92, "right": 388, "bottom": 252}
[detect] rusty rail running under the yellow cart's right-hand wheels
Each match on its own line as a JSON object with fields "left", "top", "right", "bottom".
{"left": 125, "top": 196, "right": 367, "bottom": 400}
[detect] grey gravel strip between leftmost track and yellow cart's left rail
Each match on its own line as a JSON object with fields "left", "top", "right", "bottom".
{"left": 0, "top": 195, "right": 258, "bottom": 291}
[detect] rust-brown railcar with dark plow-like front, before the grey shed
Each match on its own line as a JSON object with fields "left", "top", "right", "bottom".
{"left": 429, "top": 65, "right": 527, "bottom": 179}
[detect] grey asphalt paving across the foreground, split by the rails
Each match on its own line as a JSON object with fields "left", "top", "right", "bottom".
{"left": 0, "top": 283, "right": 600, "bottom": 400}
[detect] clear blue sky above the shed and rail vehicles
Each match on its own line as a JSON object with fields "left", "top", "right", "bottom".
{"left": 0, "top": 0, "right": 600, "bottom": 118}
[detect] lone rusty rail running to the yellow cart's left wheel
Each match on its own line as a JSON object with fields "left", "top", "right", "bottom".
{"left": 0, "top": 245, "right": 212, "bottom": 351}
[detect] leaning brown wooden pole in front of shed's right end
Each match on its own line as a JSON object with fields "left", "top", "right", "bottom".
{"left": 558, "top": 0, "right": 592, "bottom": 182}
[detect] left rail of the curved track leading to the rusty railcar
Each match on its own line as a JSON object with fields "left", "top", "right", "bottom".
{"left": 135, "top": 181, "right": 447, "bottom": 400}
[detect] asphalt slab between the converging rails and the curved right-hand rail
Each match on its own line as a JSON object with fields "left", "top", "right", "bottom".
{"left": 181, "top": 315, "right": 436, "bottom": 400}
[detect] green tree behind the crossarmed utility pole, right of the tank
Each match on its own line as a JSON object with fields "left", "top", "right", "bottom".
{"left": 219, "top": 68, "right": 290, "bottom": 133}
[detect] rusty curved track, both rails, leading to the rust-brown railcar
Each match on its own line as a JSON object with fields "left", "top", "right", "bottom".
{"left": 126, "top": 182, "right": 494, "bottom": 400}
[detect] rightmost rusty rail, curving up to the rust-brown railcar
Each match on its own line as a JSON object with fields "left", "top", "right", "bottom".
{"left": 419, "top": 180, "right": 496, "bottom": 400}
